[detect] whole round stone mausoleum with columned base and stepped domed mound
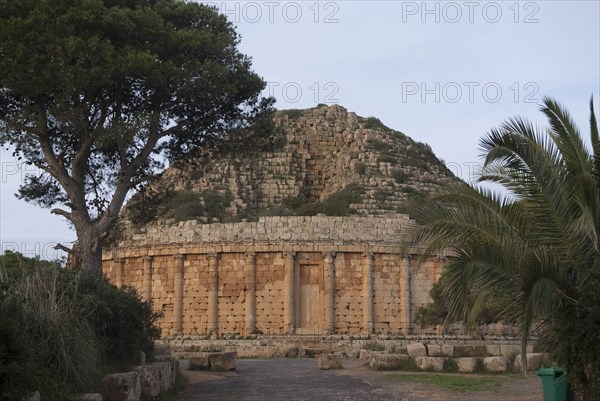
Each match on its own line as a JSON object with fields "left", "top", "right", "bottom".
{"left": 103, "top": 106, "right": 458, "bottom": 336}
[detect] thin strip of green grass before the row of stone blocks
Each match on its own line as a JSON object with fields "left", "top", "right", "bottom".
{"left": 385, "top": 373, "right": 521, "bottom": 393}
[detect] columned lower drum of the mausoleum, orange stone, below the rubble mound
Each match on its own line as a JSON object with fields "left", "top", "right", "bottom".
{"left": 104, "top": 214, "right": 442, "bottom": 336}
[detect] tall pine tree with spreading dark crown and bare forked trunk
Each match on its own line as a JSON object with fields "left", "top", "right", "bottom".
{"left": 0, "top": 0, "right": 273, "bottom": 274}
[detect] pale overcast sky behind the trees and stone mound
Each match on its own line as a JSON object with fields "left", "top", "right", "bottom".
{"left": 0, "top": 0, "right": 600, "bottom": 258}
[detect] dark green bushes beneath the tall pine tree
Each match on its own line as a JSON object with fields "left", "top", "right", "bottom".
{"left": 0, "top": 252, "right": 160, "bottom": 401}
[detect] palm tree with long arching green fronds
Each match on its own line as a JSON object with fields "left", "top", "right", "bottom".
{"left": 414, "top": 98, "right": 600, "bottom": 400}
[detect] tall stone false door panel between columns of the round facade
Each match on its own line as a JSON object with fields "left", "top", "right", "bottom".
{"left": 296, "top": 264, "right": 323, "bottom": 335}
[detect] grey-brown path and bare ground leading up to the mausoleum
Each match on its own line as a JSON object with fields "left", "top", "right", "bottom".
{"left": 178, "top": 359, "right": 543, "bottom": 401}
